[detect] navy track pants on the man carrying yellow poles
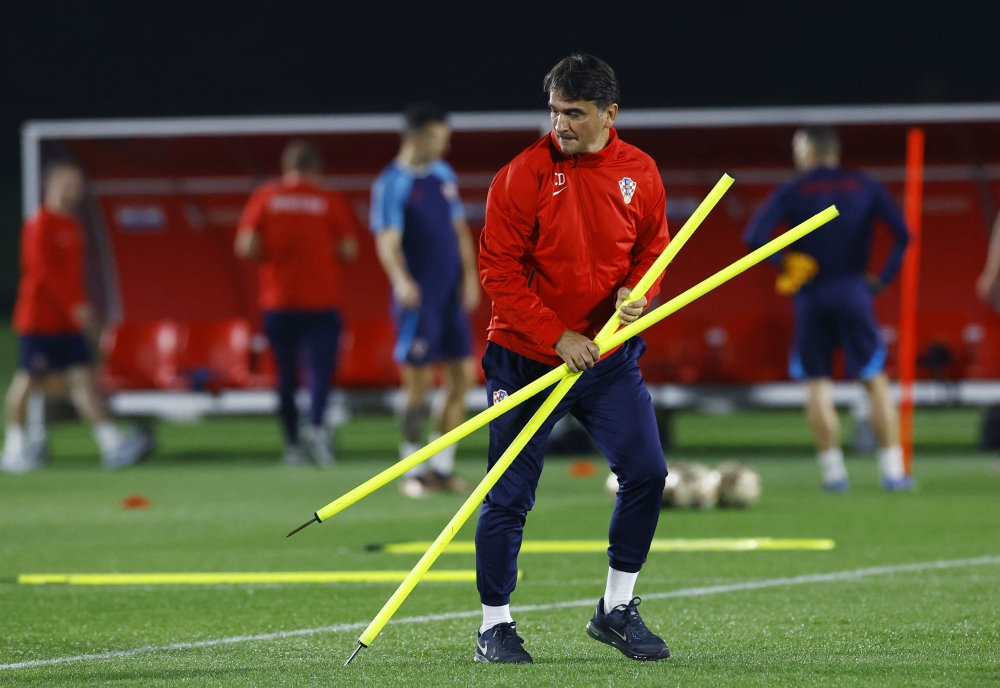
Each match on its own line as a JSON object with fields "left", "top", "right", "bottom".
{"left": 476, "top": 338, "right": 667, "bottom": 606}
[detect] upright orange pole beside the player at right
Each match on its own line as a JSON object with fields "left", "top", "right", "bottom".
{"left": 899, "top": 127, "right": 924, "bottom": 475}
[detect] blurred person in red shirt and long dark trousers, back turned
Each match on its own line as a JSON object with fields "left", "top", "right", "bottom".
{"left": 235, "top": 141, "right": 358, "bottom": 466}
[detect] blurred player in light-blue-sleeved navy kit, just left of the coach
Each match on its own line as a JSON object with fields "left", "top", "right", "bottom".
{"left": 371, "top": 103, "right": 479, "bottom": 497}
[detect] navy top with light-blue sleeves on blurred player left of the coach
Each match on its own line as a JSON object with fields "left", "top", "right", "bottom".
{"left": 369, "top": 160, "right": 465, "bottom": 302}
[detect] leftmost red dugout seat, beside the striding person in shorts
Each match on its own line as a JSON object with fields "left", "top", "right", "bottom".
{"left": 101, "top": 320, "right": 179, "bottom": 389}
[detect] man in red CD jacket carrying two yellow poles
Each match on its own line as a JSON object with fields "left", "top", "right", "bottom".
{"left": 475, "top": 55, "right": 670, "bottom": 663}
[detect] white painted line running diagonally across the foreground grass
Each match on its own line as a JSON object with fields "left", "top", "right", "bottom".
{"left": 0, "top": 556, "right": 1000, "bottom": 670}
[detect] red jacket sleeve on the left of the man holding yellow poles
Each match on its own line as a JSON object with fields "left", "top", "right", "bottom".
{"left": 479, "top": 165, "right": 567, "bottom": 347}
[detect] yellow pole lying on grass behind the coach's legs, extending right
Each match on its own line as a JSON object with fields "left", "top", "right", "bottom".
{"left": 377, "top": 538, "right": 835, "bottom": 552}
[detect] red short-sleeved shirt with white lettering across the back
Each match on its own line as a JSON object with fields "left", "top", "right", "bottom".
{"left": 239, "top": 181, "right": 356, "bottom": 310}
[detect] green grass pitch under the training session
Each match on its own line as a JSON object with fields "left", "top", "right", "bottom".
{"left": 0, "top": 411, "right": 1000, "bottom": 686}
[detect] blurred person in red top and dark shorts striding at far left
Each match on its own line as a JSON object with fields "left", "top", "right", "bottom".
{"left": 0, "top": 163, "right": 153, "bottom": 473}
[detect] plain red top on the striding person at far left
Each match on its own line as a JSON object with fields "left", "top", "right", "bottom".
{"left": 14, "top": 207, "right": 87, "bottom": 334}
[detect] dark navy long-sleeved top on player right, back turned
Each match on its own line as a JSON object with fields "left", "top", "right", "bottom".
{"left": 743, "top": 167, "right": 909, "bottom": 290}
